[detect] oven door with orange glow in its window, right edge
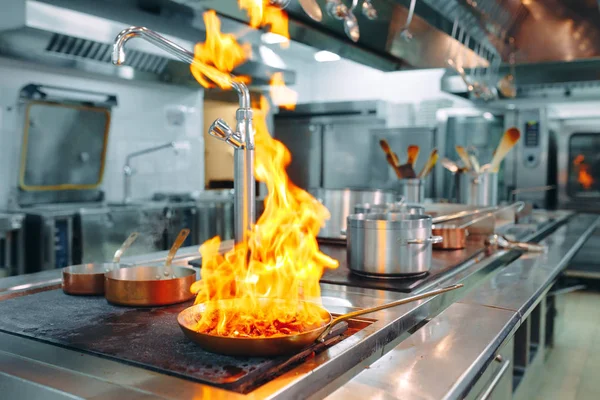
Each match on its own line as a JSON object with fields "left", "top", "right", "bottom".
{"left": 558, "top": 119, "right": 600, "bottom": 212}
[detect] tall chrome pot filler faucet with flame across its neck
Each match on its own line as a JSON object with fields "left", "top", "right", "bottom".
{"left": 112, "top": 26, "right": 256, "bottom": 243}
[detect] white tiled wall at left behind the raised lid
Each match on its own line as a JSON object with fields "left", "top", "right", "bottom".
{"left": 0, "top": 58, "right": 204, "bottom": 209}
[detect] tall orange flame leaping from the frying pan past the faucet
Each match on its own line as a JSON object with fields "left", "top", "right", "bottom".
{"left": 191, "top": 9, "right": 338, "bottom": 337}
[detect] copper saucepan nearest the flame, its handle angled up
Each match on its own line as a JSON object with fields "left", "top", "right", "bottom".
{"left": 104, "top": 229, "right": 196, "bottom": 306}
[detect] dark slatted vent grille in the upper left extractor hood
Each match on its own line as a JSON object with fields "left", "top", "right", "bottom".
{"left": 46, "top": 33, "right": 169, "bottom": 75}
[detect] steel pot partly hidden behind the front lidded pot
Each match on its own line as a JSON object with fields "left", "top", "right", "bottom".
{"left": 310, "top": 189, "right": 399, "bottom": 239}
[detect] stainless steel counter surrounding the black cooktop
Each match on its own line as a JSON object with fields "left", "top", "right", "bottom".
{"left": 0, "top": 212, "right": 599, "bottom": 399}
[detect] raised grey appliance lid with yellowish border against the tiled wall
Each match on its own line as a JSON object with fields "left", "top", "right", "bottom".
{"left": 17, "top": 84, "right": 117, "bottom": 206}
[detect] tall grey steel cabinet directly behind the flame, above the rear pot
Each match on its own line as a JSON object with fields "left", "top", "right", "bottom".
{"left": 274, "top": 101, "right": 402, "bottom": 189}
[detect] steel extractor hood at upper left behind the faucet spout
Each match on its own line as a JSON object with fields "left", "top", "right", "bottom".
{"left": 0, "top": 0, "right": 295, "bottom": 87}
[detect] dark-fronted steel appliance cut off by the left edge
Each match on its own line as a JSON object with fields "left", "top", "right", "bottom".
{"left": 0, "top": 212, "right": 25, "bottom": 276}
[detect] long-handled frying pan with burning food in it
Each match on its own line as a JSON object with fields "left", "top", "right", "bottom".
{"left": 177, "top": 284, "right": 463, "bottom": 357}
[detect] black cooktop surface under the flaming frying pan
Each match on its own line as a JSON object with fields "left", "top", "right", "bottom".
{"left": 0, "top": 289, "right": 356, "bottom": 393}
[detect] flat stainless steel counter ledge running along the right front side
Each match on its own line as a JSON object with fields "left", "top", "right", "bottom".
{"left": 327, "top": 215, "right": 600, "bottom": 400}
